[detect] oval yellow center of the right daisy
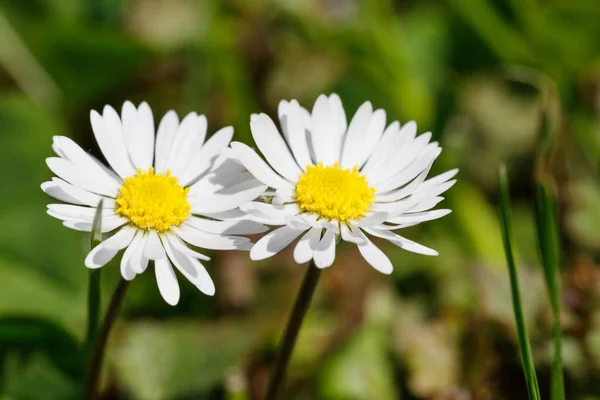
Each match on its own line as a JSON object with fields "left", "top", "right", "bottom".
{"left": 296, "top": 163, "right": 375, "bottom": 222}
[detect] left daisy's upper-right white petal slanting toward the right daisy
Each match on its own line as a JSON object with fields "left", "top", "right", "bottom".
{"left": 179, "top": 126, "right": 233, "bottom": 186}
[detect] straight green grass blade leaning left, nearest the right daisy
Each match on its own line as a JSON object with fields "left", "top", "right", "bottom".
{"left": 498, "top": 166, "right": 540, "bottom": 400}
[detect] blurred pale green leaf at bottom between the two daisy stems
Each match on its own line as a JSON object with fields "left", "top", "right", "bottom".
{"left": 110, "top": 321, "right": 256, "bottom": 400}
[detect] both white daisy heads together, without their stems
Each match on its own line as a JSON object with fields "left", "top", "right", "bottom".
{"left": 42, "top": 94, "right": 457, "bottom": 305}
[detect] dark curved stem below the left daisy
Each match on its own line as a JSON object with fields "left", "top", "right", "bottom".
{"left": 85, "top": 278, "right": 129, "bottom": 400}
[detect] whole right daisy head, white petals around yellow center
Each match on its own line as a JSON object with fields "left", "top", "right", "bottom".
{"left": 231, "top": 94, "right": 457, "bottom": 274}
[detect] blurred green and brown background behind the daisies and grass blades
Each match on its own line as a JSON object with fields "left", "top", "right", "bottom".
{"left": 0, "top": 0, "right": 600, "bottom": 400}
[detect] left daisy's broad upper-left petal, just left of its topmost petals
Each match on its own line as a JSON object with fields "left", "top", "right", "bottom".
{"left": 90, "top": 106, "right": 135, "bottom": 178}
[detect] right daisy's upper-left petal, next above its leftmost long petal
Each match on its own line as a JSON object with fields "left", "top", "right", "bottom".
{"left": 250, "top": 114, "right": 302, "bottom": 182}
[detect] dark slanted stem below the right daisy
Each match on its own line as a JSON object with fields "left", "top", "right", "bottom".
{"left": 265, "top": 261, "right": 321, "bottom": 400}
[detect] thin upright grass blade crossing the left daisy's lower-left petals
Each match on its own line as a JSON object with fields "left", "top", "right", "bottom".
{"left": 85, "top": 200, "right": 102, "bottom": 354}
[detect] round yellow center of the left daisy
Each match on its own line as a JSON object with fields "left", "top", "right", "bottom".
{"left": 116, "top": 168, "right": 192, "bottom": 232}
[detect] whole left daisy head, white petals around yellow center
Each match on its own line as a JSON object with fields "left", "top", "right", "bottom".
{"left": 42, "top": 102, "right": 266, "bottom": 305}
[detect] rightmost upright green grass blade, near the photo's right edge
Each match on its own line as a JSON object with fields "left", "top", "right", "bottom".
{"left": 536, "top": 181, "right": 565, "bottom": 400}
